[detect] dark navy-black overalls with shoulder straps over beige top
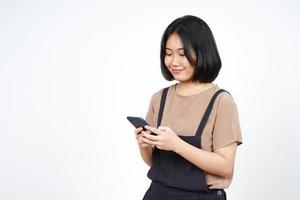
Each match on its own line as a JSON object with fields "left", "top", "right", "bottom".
{"left": 143, "top": 88, "right": 226, "bottom": 200}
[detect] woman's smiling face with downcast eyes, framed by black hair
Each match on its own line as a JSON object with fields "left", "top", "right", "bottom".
{"left": 165, "top": 33, "right": 195, "bottom": 82}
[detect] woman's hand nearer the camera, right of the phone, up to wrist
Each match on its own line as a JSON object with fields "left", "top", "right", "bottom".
{"left": 143, "top": 126, "right": 181, "bottom": 151}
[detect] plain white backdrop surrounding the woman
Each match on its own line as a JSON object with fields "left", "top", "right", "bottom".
{"left": 0, "top": 0, "right": 300, "bottom": 200}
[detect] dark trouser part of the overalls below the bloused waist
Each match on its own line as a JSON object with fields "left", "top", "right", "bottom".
{"left": 143, "top": 181, "right": 226, "bottom": 200}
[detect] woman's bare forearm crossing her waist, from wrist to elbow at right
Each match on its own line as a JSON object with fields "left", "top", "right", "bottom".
{"left": 175, "top": 140, "right": 233, "bottom": 177}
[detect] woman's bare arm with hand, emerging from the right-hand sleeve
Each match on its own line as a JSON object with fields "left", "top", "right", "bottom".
{"left": 142, "top": 126, "right": 237, "bottom": 177}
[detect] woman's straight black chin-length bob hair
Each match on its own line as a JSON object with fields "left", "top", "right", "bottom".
{"left": 160, "top": 15, "right": 222, "bottom": 83}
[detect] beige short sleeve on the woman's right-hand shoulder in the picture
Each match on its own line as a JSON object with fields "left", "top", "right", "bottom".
{"left": 213, "top": 92, "right": 242, "bottom": 150}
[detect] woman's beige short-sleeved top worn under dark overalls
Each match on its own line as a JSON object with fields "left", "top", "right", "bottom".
{"left": 145, "top": 84, "right": 242, "bottom": 189}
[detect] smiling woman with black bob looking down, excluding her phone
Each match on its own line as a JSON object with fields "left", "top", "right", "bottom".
{"left": 135, "top": 15, "right": 242, "bottom": 200}
